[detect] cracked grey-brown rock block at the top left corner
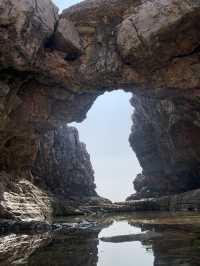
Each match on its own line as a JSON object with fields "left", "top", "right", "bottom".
{"left": 0, "top": 0, "right": 58, "bottom": 69}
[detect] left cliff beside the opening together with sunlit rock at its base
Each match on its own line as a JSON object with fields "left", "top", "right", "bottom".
{"left": 0, "top": 125, "right": 98, "bottom": 222}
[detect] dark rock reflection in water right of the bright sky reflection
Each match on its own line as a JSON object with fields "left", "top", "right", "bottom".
{"left": 137, "top": 225, "right": 200, "bottom": 266}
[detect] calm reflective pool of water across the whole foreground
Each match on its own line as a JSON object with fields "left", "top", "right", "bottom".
{"left": 0, "top": 213, "right": 200, "bottom": 266}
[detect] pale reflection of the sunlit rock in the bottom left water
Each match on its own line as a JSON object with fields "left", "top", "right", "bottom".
{"left": 0, "top": 233, "right": 50, "bottom": 266}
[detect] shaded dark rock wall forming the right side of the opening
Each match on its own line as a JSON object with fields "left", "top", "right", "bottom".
{"left": 130, "top": 92, "right": 200, "bottom": 199}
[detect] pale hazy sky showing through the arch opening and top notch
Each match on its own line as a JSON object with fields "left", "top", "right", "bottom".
{"left": 54, "top": 0, "right": 141, "bottom": 201}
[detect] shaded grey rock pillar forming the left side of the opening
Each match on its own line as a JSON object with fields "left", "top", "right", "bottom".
{"left": 32, "top": 126, "right": 97, "bottom": 200}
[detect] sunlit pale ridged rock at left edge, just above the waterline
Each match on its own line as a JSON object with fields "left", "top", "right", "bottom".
{"left": 0, "top": 172, "right": 52, "bottom": 222}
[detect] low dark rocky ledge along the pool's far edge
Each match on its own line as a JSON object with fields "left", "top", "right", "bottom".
{"left": 0, "top": 187, "right": 200, "bottom": 234}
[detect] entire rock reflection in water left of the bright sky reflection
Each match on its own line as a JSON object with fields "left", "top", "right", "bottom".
{"left": 0, "top": 231, "right": 99, "bottom": 266}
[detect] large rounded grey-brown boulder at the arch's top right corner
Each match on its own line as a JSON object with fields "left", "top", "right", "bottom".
{"left": 117, "top": 0, "right": 200, "bottom": 68}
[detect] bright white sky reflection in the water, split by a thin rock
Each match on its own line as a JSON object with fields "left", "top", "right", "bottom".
{"left": 97, "top": 221, "right": 154, "bottom": 266}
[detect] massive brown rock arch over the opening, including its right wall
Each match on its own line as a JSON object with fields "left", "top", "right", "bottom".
{"left": 0, "top": 0, "right": 200, "bottom": 220}
